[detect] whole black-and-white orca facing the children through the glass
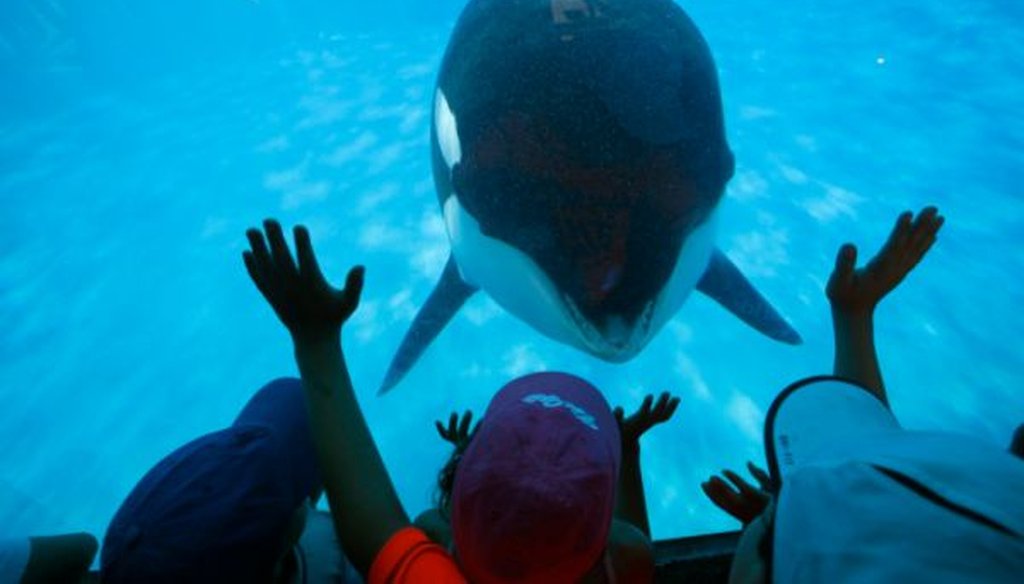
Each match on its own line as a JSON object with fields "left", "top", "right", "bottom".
{"left": 380, "top": 0, "right": 801, "bottom": 393}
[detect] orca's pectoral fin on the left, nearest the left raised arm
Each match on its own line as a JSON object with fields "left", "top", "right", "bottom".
{"left": 377, "top": 255, "right": 476, "bottom": 395}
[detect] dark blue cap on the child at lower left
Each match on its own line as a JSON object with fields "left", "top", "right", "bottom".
{"left": 100, "top": 378, "right": 321, "bottom": 584}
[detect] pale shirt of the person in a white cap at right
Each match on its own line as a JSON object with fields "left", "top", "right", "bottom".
{"left": 773, "top": 431, "right": 1024, "bottom": 584}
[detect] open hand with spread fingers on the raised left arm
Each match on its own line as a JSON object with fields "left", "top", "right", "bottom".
{"left": 242, "top": 219, "right": 364, "bottom": 342}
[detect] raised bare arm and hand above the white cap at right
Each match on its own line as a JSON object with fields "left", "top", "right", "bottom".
{"left": 825, "top": 207, "right": 944, "bottom": 407}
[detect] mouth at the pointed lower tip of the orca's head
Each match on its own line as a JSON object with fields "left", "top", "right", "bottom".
{"left": 562, "top": 293, "right": 657, "bottom": 362}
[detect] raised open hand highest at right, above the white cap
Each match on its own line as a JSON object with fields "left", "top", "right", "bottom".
{"left": 825, "top": 207, "right": 945, "bottom": 315}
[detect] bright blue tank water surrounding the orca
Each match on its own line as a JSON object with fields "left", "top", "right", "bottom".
{"left": 0, "top": 0, "right": 1024, "bottom": 538}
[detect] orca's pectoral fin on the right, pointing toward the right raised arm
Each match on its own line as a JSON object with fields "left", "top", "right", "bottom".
{"left": 697, "top": 249, "right": 803, "bottom": 344}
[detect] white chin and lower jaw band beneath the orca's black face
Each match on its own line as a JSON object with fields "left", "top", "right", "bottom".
{"left": 443, "top": 195, "right": 714, "bottom": 363}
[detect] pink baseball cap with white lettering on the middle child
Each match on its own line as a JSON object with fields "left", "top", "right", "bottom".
{"left": 452, "top": 373, "right": 622, "bottom": 584}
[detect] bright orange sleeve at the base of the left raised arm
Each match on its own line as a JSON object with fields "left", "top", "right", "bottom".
{"left": 367, "top": 528, "right": 467, "bottom": 584}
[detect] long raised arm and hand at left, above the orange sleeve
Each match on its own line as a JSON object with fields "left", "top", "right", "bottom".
{"left": 243, "top": 219, "right": 410, "bottom": 576}
